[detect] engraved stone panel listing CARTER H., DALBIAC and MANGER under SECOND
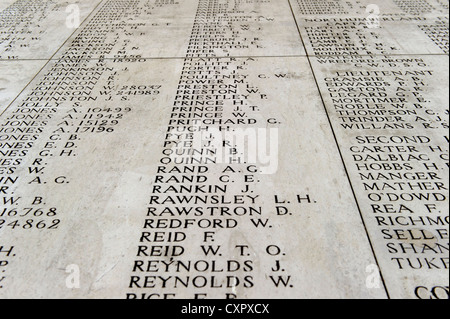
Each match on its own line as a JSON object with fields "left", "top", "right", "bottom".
{"left": 313, "top": 56, "right": 449, "bottom": 298}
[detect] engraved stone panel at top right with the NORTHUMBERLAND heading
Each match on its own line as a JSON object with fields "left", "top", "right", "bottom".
{"left": 291, "top": 0, "right": 448, "bottom": 57}
